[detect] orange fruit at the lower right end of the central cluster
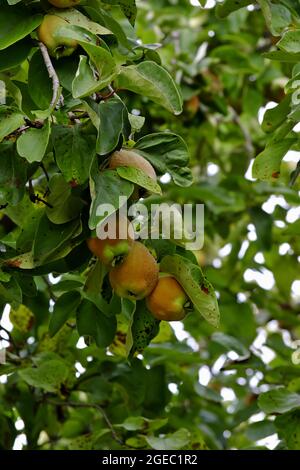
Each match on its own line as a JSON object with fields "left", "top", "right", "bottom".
{"left": 146, "top": 276, "right": 189, "bottom": 321}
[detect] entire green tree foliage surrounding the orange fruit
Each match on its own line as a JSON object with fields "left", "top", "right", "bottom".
{"left": 0, "top": 0, "right": 300, "bottom": 450}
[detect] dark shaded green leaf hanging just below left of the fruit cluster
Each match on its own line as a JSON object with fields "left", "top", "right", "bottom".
{"left": 77, "top": 299, "right": 117, "bottom": 348}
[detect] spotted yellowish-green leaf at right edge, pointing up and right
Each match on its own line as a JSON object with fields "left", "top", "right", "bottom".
{"left": 252, "top": 139, "right": 296, "bottom": 181}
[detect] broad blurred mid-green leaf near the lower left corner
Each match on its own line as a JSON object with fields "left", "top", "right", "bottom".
{"left": 18, "top": 359, "right": 69, "bottom": 393}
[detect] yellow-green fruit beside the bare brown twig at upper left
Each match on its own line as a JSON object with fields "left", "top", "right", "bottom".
{"left": 37, "top": 15, "right": 78, "bottom": 59}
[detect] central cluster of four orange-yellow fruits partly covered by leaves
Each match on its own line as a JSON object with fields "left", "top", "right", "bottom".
{"left": 88, "top": 149, "right": 189, "bottom": 321}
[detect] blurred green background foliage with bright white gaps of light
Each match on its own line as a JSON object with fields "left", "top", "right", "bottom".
{"left": 0, "top": 0, "right": 300, "bottom": 450}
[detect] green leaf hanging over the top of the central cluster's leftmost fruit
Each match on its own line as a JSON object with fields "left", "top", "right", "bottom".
{"left": 89, "top": 170, "right": 134, "bottom": 230}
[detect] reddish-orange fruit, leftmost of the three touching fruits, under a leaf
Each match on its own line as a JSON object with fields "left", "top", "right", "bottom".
{"left": 87, "top": 214, "right": 134, "bottom": 268}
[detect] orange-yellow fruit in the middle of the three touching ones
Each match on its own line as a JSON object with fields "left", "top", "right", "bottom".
{"left": 109, "top": 242, "right": 158, "bottom": 300}
